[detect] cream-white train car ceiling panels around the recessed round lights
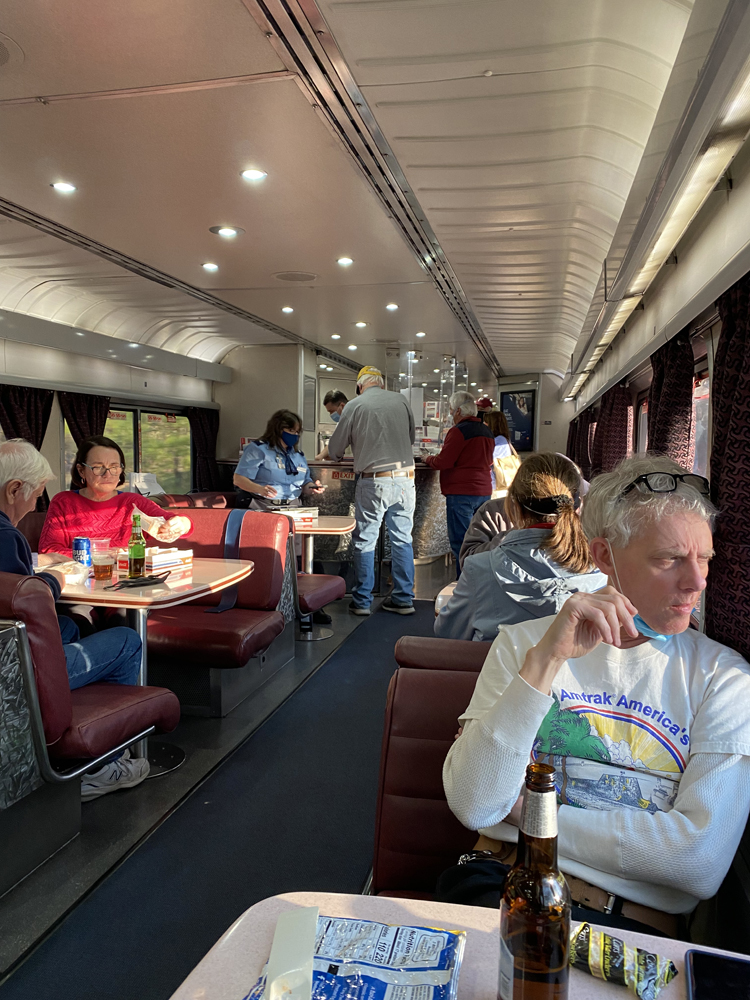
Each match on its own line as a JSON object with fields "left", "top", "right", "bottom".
{"left": 0, "top": 0, "right": 704, "bottom": 384}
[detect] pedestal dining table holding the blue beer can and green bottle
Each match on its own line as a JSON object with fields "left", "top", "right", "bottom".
{"left": 59, "top": 558, "right": 254, "bottom": 777}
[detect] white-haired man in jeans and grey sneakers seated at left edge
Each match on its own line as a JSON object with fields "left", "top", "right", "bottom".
{"left": 0, "top": 438, "right": 149, "bottom": 801}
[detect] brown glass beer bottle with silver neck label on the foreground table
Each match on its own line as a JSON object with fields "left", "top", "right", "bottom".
{"left": 498, "top": 763, "right": 570, "bottom": 1000}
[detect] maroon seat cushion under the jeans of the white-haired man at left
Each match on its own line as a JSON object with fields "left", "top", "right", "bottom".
{"left": 49, "top": 684, "right": 180, "bottom": 759}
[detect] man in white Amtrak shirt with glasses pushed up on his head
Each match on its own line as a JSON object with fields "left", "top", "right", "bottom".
{"left": 443, "top": 455, "right": 750, "bottom": 934}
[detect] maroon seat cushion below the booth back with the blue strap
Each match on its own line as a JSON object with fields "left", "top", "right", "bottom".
{"left": 148, "top": 605, "right": 284, "bottom": 669}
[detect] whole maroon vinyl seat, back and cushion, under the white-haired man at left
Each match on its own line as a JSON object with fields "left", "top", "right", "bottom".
{"left": 0, "top": 573, "right": 180, "bottom": 764}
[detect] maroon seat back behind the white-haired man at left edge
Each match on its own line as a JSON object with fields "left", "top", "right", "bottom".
{"left": 0, "top": 573, "right": 73, "bottom": 745}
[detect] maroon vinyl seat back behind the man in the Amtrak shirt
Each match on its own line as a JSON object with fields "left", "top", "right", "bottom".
{"left": 372, "top": 636, "right": 491, "bottom": 899}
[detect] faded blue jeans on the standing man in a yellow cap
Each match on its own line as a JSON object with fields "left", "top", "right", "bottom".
{"left": 352, "top": 476, "right": 416, "bottom": 608}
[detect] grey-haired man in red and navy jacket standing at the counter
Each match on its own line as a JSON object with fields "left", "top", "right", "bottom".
{"left": 425, "top": 392, "right": 495, "bottom": 579}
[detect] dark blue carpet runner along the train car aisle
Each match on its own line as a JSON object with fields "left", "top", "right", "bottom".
{"left": 0, "top": 601, "right": 434, "bottom": 1000}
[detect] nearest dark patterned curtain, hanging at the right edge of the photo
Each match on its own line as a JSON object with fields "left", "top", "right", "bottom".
{"left": 706, "top": 275, "right": 750, "bottom": 659}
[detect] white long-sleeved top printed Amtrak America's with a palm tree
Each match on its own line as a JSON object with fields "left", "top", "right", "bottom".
{"left": 443, "top": 618, "right": 750, "bottom": 913}
